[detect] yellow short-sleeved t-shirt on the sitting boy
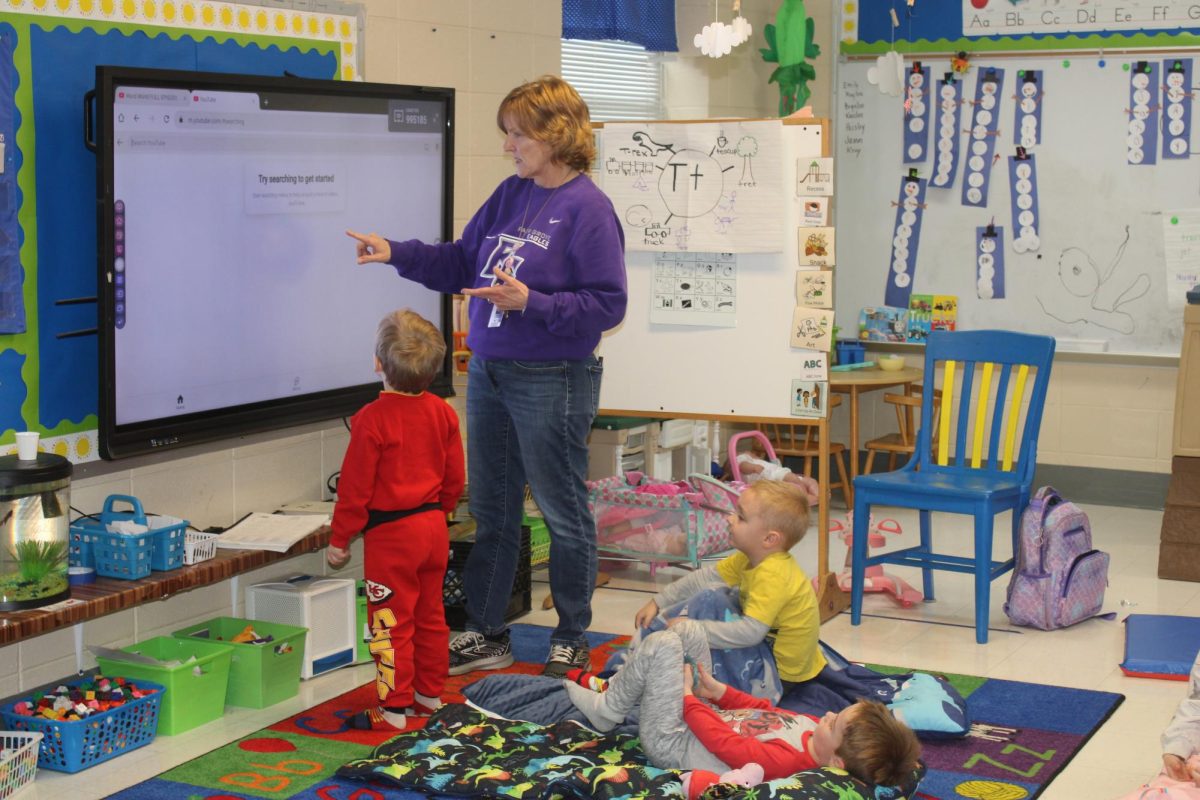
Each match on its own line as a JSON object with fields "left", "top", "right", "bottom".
{"left": 716, "top": 553, "right": 826, "bottom": 682}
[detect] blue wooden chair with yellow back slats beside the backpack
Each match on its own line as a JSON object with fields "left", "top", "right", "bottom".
{"left": 850, "top": 331, "right": 1055, "bottom": 644}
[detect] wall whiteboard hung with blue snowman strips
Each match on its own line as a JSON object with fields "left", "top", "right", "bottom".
{"left": 835, "top": 54, "right": 1200, "bottom": 356}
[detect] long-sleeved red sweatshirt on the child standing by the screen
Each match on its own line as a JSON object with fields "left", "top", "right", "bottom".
{"left": 330, "top": 391, "right": 466, "bottom": 549}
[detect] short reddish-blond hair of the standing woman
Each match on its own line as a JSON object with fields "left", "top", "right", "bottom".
{"left": 496, "top": 76, "right": 596, "bottom": 173}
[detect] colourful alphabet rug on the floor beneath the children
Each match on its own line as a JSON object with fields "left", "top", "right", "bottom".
{"left": 110, "top": 625, "right": 1124, "bottom": 800}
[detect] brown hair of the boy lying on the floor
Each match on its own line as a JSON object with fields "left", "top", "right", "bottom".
{"left": 835, "top": 700, "right": 920, "bottom": 786}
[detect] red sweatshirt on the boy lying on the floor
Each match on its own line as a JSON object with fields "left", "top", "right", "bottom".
{"left": 683, "top": 686, "right": 820, "bottom": 798}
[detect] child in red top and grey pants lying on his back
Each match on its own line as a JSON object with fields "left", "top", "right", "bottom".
{"left": 564, "top": 620, "right": 920, "bottom": 800}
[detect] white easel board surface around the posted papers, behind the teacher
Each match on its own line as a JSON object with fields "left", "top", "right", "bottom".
{"left": 600, "top": 120, "right": 828, "bottom": 419}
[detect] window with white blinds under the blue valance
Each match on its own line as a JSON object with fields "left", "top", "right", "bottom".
{"left": 563, "top": 38, "right": 662, "bottom": 122}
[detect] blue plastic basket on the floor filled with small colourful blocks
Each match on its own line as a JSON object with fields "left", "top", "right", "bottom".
{"left": 0, "top": 680, "right": 164, "bottom": 772}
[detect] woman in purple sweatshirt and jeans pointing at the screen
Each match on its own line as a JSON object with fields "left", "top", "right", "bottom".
{"left": 347, "top": 76, "right": 626, "bottom": 676}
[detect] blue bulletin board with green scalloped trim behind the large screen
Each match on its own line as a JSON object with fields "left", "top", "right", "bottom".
{"left": 0, "top": 0, "right": 361, "bottom": 462}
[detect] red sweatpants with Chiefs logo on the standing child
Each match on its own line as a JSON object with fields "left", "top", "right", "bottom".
{"left": 364, "top": 511, "right": 450, "bottom": 709}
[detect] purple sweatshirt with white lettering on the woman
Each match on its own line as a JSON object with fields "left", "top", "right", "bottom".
{"left": 389, "top": 175, "right": 626, "bottom": 361}
